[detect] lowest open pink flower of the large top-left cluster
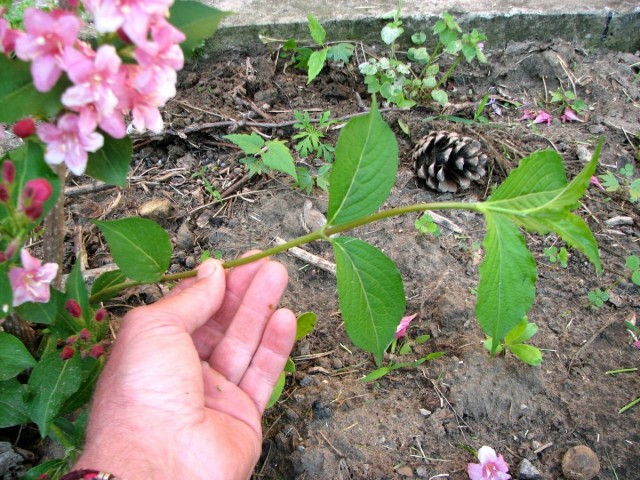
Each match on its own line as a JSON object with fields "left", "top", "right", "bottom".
{"left": 37, "top": 113, "right": 104, "bottom": 175}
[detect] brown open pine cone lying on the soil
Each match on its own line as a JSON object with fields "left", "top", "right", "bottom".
{"left": 411, "top": 130, "right": 487, "bottom": 193}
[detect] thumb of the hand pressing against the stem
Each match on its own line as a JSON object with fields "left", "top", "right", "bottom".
{"left": 131, "top": 260, "right": 226, "bottom": 333}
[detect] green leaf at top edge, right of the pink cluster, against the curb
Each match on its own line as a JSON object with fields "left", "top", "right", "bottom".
{"left": 169, "top": 0, "right": 231, "bottom": 58}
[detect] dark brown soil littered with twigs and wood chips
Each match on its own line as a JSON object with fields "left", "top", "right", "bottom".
{"left": 5, "top": 36, "right": 640, "bottom": 480}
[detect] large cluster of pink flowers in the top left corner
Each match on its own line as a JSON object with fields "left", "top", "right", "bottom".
{"left": 0, "top": 0, "right": 185, "bottom": 175}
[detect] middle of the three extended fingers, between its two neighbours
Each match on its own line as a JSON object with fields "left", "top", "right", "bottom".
{"left": 209, "top": 261, "right": 288, "bottom": 385}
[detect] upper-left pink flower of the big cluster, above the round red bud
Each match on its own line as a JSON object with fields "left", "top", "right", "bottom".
{"left": 15, "top": 8, "right": 81, "bottom": 92}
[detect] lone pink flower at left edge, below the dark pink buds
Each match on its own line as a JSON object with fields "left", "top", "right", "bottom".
{"left": 9, "top": 248, "right": 58, "bottom": 307}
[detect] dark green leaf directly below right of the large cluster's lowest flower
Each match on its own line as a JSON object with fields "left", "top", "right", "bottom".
{"left": 87, "top": 134, "right": 133, "bottom": 187}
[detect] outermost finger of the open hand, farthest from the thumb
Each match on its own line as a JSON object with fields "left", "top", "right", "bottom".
{"left": 239, "top": 309, "right": 296, "bottom": 414}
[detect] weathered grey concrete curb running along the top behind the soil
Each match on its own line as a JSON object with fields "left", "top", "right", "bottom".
{"left": 204, "top": 0, "right": 640, "bottom": 53}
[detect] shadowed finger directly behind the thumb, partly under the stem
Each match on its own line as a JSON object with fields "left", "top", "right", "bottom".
{"left": 193, "top": 250, "right": 269, "bottom": 359}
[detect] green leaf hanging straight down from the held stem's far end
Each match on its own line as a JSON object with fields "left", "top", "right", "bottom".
{"left": 476, "top": 213, "right": 536, "bottom": 353}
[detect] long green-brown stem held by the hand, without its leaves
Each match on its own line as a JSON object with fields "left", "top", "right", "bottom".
{"left": 89, "top": 202, "right": 480, "bottom": 303}
